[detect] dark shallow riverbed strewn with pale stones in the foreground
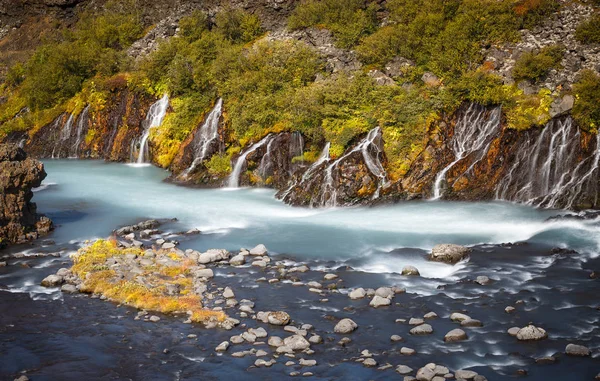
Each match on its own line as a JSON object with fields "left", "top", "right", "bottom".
{"left": 0, "top": 215, "right": 600, "bottom": 381}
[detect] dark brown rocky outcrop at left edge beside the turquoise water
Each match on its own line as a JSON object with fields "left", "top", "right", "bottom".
{"left": 0, "top": 144, "right": 52, "bottom": 245}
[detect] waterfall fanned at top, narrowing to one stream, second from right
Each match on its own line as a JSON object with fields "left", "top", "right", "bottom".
{"left": 433, "top": 103, "right": 502, "bottom": 200}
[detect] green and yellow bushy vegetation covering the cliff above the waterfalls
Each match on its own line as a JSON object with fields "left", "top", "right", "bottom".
{"left": 0, "top": 0, "right": 598, "bottom": 178}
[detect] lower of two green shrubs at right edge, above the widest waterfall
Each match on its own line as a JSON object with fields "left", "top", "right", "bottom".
{"left": 573, "top": 70, "right": 600, "bottom": 132}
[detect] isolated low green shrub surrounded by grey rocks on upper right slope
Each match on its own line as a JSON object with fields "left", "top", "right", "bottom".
{"left": 513, "top": 45, "right": 565, "bottom": 82}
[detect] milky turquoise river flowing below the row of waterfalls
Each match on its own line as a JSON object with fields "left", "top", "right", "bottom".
{"left": 34, "top": 160, "right": 600, "bottom": 277}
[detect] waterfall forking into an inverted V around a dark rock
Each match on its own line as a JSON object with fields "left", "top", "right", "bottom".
{"left": 320, "top": 127, "right": 387, "bottom": 207}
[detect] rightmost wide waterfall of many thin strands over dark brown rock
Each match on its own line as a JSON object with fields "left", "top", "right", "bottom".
{"left": 496, "top": 117, "right": 600, "bottom": 208}
